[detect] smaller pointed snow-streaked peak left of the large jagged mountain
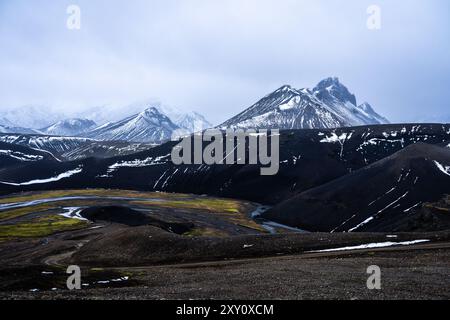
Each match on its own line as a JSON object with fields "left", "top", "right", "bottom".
{"left": 85, "top": 107, "right": 179, "bottom": 143}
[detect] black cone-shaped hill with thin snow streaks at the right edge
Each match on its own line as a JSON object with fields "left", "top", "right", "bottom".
{"left": 263, "top": 143, "right": 450, "bottom": 232}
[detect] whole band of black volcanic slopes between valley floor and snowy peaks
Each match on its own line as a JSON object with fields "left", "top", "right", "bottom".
{"left": 0, "top": 124, "right": 450, "bottom": 231}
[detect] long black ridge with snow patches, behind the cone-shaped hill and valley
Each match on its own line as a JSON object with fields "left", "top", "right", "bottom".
{"left": 0, "top": 124, "right": 450, "bottom": 204}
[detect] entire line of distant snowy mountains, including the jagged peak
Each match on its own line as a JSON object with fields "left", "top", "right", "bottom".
{"left": 0, "top": 78, "right": 428, "bottom": 144}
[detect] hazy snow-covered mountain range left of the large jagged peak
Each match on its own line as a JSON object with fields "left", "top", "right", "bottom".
{"left": 0, "top": 104, "right": 212, "bottom": 144}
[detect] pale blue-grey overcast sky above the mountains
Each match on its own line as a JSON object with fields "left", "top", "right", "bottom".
{"left": 0, "top": 0, "right": 450, "bottom": 123}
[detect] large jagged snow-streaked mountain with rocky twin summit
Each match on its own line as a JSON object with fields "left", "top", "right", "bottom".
{"left": 219, "top": 78, "right": 388, "bottom": 129}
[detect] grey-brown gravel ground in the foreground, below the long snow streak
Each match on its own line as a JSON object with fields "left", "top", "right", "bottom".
{"left": 0, "top": 242, "right": 450, "bottom": 300}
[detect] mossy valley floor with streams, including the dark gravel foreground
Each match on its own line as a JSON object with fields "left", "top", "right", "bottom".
{"left": 0, "top": 189, "right": 450, "bottom": 299}
